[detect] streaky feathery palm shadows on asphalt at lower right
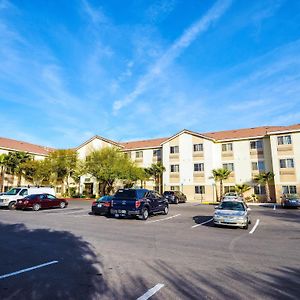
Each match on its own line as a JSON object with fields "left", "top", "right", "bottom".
{"left": 148, "top": 261, "right": 300, "bottom": 300}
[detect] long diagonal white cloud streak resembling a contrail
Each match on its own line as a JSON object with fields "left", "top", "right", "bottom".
{"left": 113, "top": 0, "right": 231, "bottom": 113}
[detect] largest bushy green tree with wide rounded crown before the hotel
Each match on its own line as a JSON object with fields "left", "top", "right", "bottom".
{"left": 85, "top": 147, "right": 137, "bottom": 195}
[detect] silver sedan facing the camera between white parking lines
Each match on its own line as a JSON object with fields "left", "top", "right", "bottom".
{"left": 213, "top": 200, "right": 251, "bottom": 229}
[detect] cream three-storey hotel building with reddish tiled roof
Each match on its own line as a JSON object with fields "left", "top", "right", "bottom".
{"left": 0, "top": 124, "right": 300, "bottom": 202}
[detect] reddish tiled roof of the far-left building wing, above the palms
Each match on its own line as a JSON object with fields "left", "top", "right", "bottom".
{"left": 0, "top": 137, "right": 53, "bottom": 155}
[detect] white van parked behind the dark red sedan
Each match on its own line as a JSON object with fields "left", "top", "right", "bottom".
{"left": 0, "top": 187, "right": 55, "bottom": 209}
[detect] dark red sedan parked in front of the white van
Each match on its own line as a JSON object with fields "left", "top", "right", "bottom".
{"left": 16, "top": 194, "right": 68, "bottom": 211}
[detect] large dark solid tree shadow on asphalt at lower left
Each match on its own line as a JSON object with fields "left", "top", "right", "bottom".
{"left": 0, "top": 223, "right": 146, "bottom": 300}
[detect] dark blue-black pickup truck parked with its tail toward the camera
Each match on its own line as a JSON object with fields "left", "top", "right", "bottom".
{"left": 110, "top": 189, "right": 169, "bottom": 220}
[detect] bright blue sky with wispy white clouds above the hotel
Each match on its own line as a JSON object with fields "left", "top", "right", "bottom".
{"left": 0, "top": 0, "right": 300, "bottom": 148}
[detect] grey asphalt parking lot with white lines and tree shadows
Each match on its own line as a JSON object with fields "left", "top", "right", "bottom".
{"left": 0, "top": 200, "right": 300, "bottom": 300}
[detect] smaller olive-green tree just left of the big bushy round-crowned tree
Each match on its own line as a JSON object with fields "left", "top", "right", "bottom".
{"left": 49, "top": 149, "right": 77, "bottom": 193}
